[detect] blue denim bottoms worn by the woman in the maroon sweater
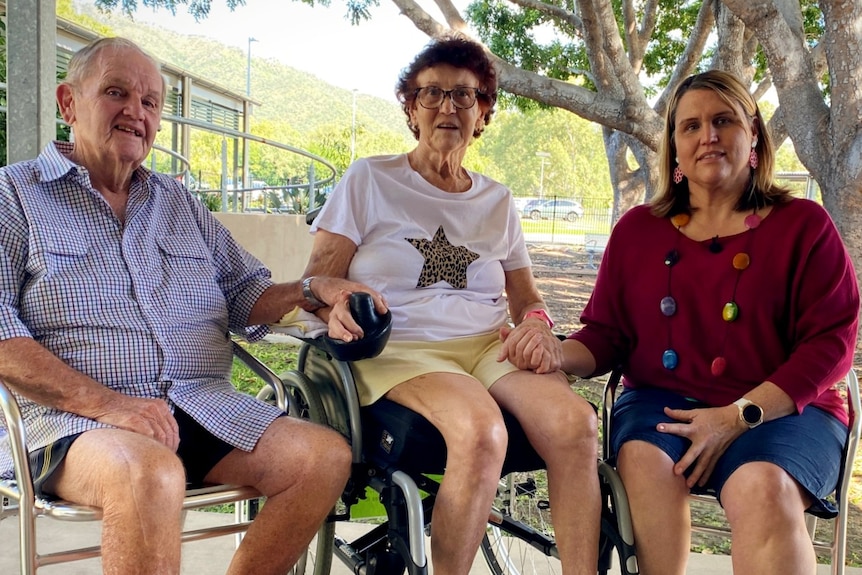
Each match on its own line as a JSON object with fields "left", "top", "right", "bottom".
{"left": 611, "top": 388, "right": 847, "bottom": 518}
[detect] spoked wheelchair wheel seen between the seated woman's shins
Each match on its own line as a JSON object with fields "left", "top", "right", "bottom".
{"left": 480, "top": 470, "right": 560, "bottom": 575}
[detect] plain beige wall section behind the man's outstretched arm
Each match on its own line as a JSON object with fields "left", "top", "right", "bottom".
{"left": 213, "top": 213, "right": 313, "bottom": 282}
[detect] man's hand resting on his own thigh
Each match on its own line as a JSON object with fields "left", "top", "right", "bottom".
{"left": 93, "top": 393, "right": 180, "bottom": 451}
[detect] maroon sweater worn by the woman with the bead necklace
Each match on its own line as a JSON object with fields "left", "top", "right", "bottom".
{"left": 569, "top": 199, "right": 859, "bottom": 423}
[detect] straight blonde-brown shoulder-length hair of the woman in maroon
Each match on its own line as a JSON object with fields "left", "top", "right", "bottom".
{"left": 651, "top": 70, "right": 790, "bottom": 217}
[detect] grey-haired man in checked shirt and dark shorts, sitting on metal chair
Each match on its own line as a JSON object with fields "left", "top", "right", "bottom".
{"left": 0, "top": 38, "right": 385, "bottom": 575}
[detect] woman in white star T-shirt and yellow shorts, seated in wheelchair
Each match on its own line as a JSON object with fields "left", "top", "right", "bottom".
{"left": 306, "top": 38, "right": 600, "bottom": 575}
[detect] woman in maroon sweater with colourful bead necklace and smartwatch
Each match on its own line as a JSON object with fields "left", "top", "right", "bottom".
{"left": 544, "top": 71, "right": 859, "bottom": 575}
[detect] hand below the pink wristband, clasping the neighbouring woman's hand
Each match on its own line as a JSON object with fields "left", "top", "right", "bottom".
{"left": 497, "top": 318, "right": 563, "bottom": 373}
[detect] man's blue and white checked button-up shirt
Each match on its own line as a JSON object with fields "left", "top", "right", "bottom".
{"left": 0, "top": 142, "right": 280, "bottom": 478}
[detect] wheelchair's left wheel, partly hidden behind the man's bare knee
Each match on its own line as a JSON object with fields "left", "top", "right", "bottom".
{"left": 258, "top": 371, "right": 335, "bottom": 575}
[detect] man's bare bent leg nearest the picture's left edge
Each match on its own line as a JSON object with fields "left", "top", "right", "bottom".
{"left": 46, "top": 429, "right": 186, "bottom": 575}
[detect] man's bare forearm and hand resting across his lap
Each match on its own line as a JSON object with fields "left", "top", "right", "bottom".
{"left": 0, "top": 337, "right": 179, "bottom": 449}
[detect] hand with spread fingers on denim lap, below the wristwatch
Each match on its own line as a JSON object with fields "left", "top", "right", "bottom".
{"left": 657, "top": 405, "right": 745, "bottom": 488}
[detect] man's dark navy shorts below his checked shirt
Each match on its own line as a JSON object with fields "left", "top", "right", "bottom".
{"left": 30, "top": 407, "right": 240, "bottom": 498}
